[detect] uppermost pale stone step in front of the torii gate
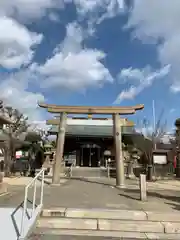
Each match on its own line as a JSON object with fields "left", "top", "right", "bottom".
{"left": 41, "top": 207, "right": 180, "bottom": 223}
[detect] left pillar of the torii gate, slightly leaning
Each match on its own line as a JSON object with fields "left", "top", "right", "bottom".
{"left": 52, "top": 113, "right": 66, "bottom": 184}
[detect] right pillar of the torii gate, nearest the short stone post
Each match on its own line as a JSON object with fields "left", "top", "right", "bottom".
{"left": 113, "top": 114, "right": 125, "bottom": 187}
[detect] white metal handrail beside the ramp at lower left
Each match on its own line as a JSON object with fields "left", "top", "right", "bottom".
{"left": 20, "top": 169, "right": 45, "bottom": 237}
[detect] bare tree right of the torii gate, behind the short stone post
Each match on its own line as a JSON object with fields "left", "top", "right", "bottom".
{"left": 133, "top": 111, "right": 167, "bottom": 180}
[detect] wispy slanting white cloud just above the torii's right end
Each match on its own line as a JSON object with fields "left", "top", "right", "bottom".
{"left": 114, "top": 65, "right": 170, "bottom": 104}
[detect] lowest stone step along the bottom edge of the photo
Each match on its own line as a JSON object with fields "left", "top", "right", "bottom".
{"left": 32, "top": 228, "right": 180, "bottom": 240}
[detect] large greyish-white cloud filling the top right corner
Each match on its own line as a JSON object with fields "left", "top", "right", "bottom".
{"left": 126, "top": 0, "right": 180, "bottom": 92}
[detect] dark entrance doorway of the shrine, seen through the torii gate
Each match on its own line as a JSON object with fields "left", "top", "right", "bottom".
{"left": 80, "top": 144, "right": 101, "bottom": 167}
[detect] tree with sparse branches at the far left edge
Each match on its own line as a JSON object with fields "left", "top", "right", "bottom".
{"left": 1, "top": 107, "right": 29, "bottom": 176}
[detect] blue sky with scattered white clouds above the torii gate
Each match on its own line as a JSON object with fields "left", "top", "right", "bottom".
{"left": 0, "top": 0, "right": 180, "bottom": 129}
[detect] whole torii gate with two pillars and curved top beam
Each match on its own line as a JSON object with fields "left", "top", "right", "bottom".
{"left": 38, "top": 103, "right": 144, "bottom": 187}
